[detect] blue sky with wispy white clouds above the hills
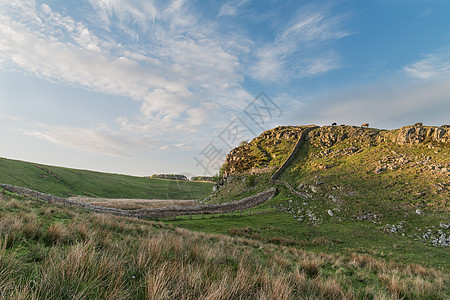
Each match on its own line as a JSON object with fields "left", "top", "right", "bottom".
{"left": 0, "top": 0, "right": 450, "bottom": 176}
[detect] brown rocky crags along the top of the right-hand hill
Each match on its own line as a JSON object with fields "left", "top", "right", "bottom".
{"left": 225, "top": 125, "right": 450, "bottom": 175}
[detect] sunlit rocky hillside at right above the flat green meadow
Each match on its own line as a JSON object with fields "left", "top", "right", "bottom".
{"left": 211, "top": 126, "right": 450, "bottom": 211}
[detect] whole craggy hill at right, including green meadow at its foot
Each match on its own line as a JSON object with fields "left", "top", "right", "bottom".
{"left": 174, "top": 126, "right": 450, "bottom": 271}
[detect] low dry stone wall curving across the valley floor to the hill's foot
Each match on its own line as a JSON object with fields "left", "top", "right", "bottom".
{"left": 0, "top": 184, "right": 276, "bottom": 219}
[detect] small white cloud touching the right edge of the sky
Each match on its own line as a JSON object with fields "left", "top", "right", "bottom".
{"left": 403, "top": 48, "right": 450, "bottom": 79}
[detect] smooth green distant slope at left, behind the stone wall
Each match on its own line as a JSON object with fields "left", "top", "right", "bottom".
{"left": 0, "top": 158, "right": 212, "bottom": 200}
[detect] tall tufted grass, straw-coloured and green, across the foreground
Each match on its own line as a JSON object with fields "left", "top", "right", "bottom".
{"left": 0, "top": 194, "right": 449, "bottom": 299}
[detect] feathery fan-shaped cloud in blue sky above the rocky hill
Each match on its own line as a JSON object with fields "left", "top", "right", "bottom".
{"left": 249, "top": 5, "right": 350, "bottom": 81}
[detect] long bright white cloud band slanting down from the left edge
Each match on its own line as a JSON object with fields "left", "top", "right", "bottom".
{"left": 0, "top": 16, "right": 166, "bottom": 99}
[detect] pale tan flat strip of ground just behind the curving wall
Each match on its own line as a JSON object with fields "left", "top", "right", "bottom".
{"left": 69, "top": 196, "right": 195, "bottom": 210}
